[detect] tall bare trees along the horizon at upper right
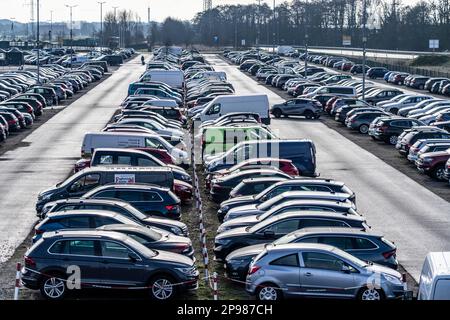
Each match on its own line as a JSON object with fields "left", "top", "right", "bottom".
{"left": 193, "top": 0, "right": 450, "bottom": 50}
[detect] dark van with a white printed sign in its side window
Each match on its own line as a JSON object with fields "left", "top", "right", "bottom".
{"left": 36, "top": 167, "right": 174, "bottom": 213}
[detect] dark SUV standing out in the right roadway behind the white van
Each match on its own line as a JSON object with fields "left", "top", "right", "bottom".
{"left": 270, "top": 98, "right": 322, "bottom": 119}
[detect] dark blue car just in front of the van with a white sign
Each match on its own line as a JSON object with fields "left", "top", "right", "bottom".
{"left": 82, "top": 184, "right": 181, "bottom": 220}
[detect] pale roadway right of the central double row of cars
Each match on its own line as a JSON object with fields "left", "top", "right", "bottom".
{"left": 207, "top": 55, "right": 450, "bottom": 281}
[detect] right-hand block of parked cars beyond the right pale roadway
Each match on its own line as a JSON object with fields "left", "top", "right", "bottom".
{"left": 225, "top": 51, "right": 450, "bottom": 183}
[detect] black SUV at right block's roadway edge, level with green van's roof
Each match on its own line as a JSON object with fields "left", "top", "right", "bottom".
{"left": 372, "top": 118, "right": 424, "bottom": 146}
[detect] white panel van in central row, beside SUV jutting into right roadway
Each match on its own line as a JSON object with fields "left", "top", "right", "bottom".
{"left": 194, "top": 94, "right": 270, "bottom": 125}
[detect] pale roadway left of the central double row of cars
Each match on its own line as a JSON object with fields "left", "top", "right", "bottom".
{"left": 0, "top": 57, "right": 148, "bottom": 262}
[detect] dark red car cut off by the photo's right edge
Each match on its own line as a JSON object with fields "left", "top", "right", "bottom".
{"left": 415, "top": 149, "right": 450, "bottom": 181}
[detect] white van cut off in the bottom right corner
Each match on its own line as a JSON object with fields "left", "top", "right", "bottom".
{"left": 417, "top": 252, "right": 450, "bottom": 300}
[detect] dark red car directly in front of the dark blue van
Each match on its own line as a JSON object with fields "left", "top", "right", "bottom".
{"left": 205, "top": 158, "right": 300, "bottom": 189}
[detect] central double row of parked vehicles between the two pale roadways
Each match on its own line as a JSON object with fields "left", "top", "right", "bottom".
{"left": 15, "top": 48, "right": 448, "bottom": 300}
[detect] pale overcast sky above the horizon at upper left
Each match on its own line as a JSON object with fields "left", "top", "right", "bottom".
{"left": 0, "top": 0, "right": 418, "bottom": 22}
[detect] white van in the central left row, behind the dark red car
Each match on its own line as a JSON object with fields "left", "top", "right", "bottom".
{"left": 81, "top": 132, "right": 189, "bottom": 163}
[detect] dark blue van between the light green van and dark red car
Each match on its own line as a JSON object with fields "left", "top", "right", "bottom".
{"left": 205, "top": 139, "right": 317, "bottom": 177}
